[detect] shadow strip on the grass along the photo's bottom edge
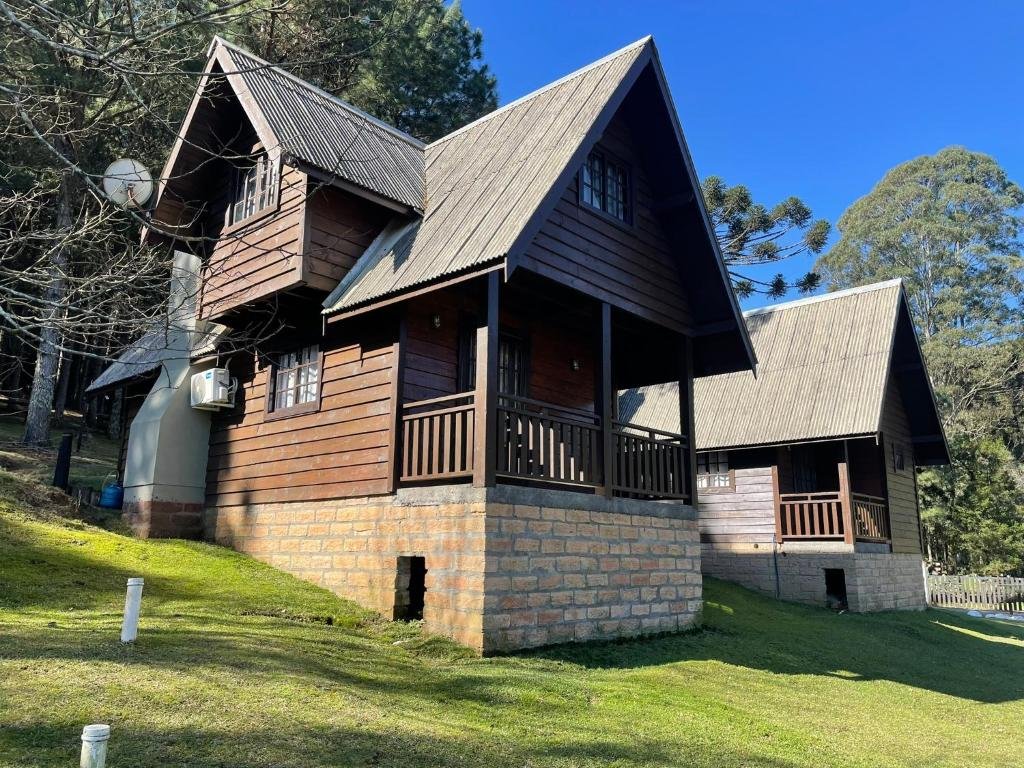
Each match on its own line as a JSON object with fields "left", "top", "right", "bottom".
{"left": 0, "top": 712, "right": 794, "bottom": 768}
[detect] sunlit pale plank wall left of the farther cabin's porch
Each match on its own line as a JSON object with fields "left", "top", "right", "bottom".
{"left": 697, "top": 462, "right": 775, "bottom": 544}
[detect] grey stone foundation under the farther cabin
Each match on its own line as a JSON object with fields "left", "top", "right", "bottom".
{"left": 700, "top": 544, "right": 925, "bottom": 611}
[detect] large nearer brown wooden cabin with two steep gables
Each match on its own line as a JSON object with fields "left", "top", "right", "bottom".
{"left": 92, "top": 38, "right": 754, "bottom": 651}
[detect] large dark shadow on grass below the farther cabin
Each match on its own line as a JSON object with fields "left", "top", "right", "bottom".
{"left": 530, "top": 579, "right": 1024, "bottom": 702}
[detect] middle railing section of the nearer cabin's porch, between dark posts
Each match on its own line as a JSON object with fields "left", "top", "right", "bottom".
{"left": 497, "top": 394, "right": 601, "bottom": 485}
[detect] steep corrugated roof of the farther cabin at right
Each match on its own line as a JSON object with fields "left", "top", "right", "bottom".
{"left": 620, "top": 281, "right": 902, "bottom": 450}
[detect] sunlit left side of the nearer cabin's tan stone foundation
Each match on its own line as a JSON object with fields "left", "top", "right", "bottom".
{"left": 205, "top": 497, "right": 484, "bottom": 650}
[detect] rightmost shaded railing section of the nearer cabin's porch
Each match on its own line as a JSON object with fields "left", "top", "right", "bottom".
{"left": 611, "top": 421, "right": 689, "bottom": 499}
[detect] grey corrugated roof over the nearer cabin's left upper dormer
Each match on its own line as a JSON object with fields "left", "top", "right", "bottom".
{"left": 211, "top": 38, "right": 424, "bottom": 211}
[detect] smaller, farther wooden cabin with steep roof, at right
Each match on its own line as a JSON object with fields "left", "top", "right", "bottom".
{"left": 621, "top": 281, "right": 949, "bottom": 610}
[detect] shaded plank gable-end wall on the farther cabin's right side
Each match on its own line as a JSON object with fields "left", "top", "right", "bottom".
{"left": 882, "top": 381, "right": 921, "bottom": 553}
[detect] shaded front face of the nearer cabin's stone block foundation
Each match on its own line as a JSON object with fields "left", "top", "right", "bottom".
{"left": 483, "top": 488, "right": 701, "bottom": 651}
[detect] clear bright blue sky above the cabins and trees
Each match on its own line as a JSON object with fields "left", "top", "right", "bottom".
{"left": 463, "top": 0, "right": 1024, "bottom": 306}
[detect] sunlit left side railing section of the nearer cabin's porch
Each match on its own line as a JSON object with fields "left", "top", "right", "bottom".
{"left": 398, "top": 392, "right": 475, "bottom": 482}
